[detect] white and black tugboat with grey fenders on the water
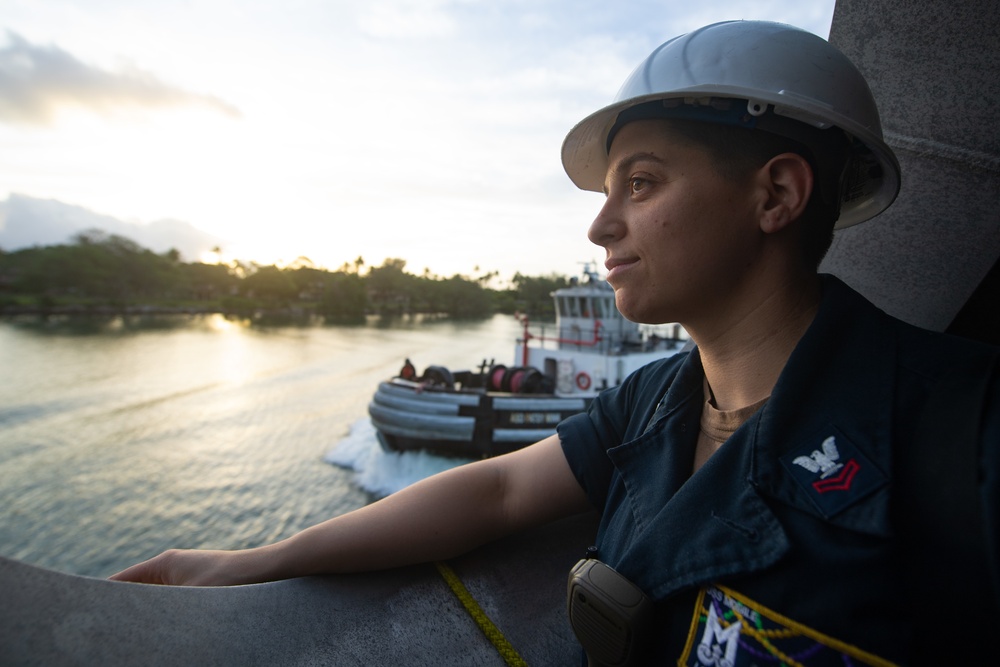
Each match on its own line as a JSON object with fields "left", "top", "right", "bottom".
{"left": 368, "top": 264, "right": 687, "bottom": 459}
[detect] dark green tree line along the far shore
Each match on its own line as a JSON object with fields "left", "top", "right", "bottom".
{"left": 0, "top": 229, "right": 569, "bottom": 322}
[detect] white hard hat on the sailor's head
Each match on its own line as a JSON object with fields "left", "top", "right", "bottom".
{"left": 562, "top": 21, "right": 900, "bottom": 228}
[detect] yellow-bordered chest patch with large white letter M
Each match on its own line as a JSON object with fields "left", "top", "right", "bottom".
{"left": 677, "top": 586, "right": 892, "bottom": 667}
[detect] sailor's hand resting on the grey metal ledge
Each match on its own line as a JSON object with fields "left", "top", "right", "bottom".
{"left": 109, "top": 549, "right": 253, "bottom": 586}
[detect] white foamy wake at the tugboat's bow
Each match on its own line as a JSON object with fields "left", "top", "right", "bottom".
{"left": 323, "top": 417, "right": 471, "bottom": 497}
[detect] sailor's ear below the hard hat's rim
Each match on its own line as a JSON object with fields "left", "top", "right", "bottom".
{"left": 757, "top": 153, "right": 813, "bottom": 234}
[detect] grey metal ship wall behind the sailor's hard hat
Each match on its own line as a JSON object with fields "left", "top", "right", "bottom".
{"left": 821, "top": 0, "right": 1000, "bottom": 330}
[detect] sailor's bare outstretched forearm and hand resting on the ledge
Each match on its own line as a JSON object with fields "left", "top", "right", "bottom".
{"left": 112, "top": 436, "right": 589, "bottom": 585}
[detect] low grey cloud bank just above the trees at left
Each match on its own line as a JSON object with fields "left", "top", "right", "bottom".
{"left": 0, "top": 194, "right": 226, "bottom": 262}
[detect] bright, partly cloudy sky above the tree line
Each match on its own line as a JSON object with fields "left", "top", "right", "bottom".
{"left": 0, "top": 0, "right": 834, "bottom": 277}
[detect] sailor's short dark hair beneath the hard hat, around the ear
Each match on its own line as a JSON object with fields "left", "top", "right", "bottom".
{"left": 669, "top": 119, "right": 850, "bottom": 271}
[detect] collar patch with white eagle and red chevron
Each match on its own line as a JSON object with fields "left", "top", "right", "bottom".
{"left": 781, "top": 431, "right": 887, "bottom": 518}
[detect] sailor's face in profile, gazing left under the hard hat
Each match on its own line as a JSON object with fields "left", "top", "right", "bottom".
{"left": 588, "top": 120, "right": 756, "bottom": 324}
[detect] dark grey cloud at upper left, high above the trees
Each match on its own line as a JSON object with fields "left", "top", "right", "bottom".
{"left": 0, "top": 30, "right": 240, "bottom": 125}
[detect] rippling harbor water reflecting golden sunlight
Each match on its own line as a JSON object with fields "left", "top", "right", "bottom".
{"left": 0, "top": 315, "right": 520, "bottom": 577}
